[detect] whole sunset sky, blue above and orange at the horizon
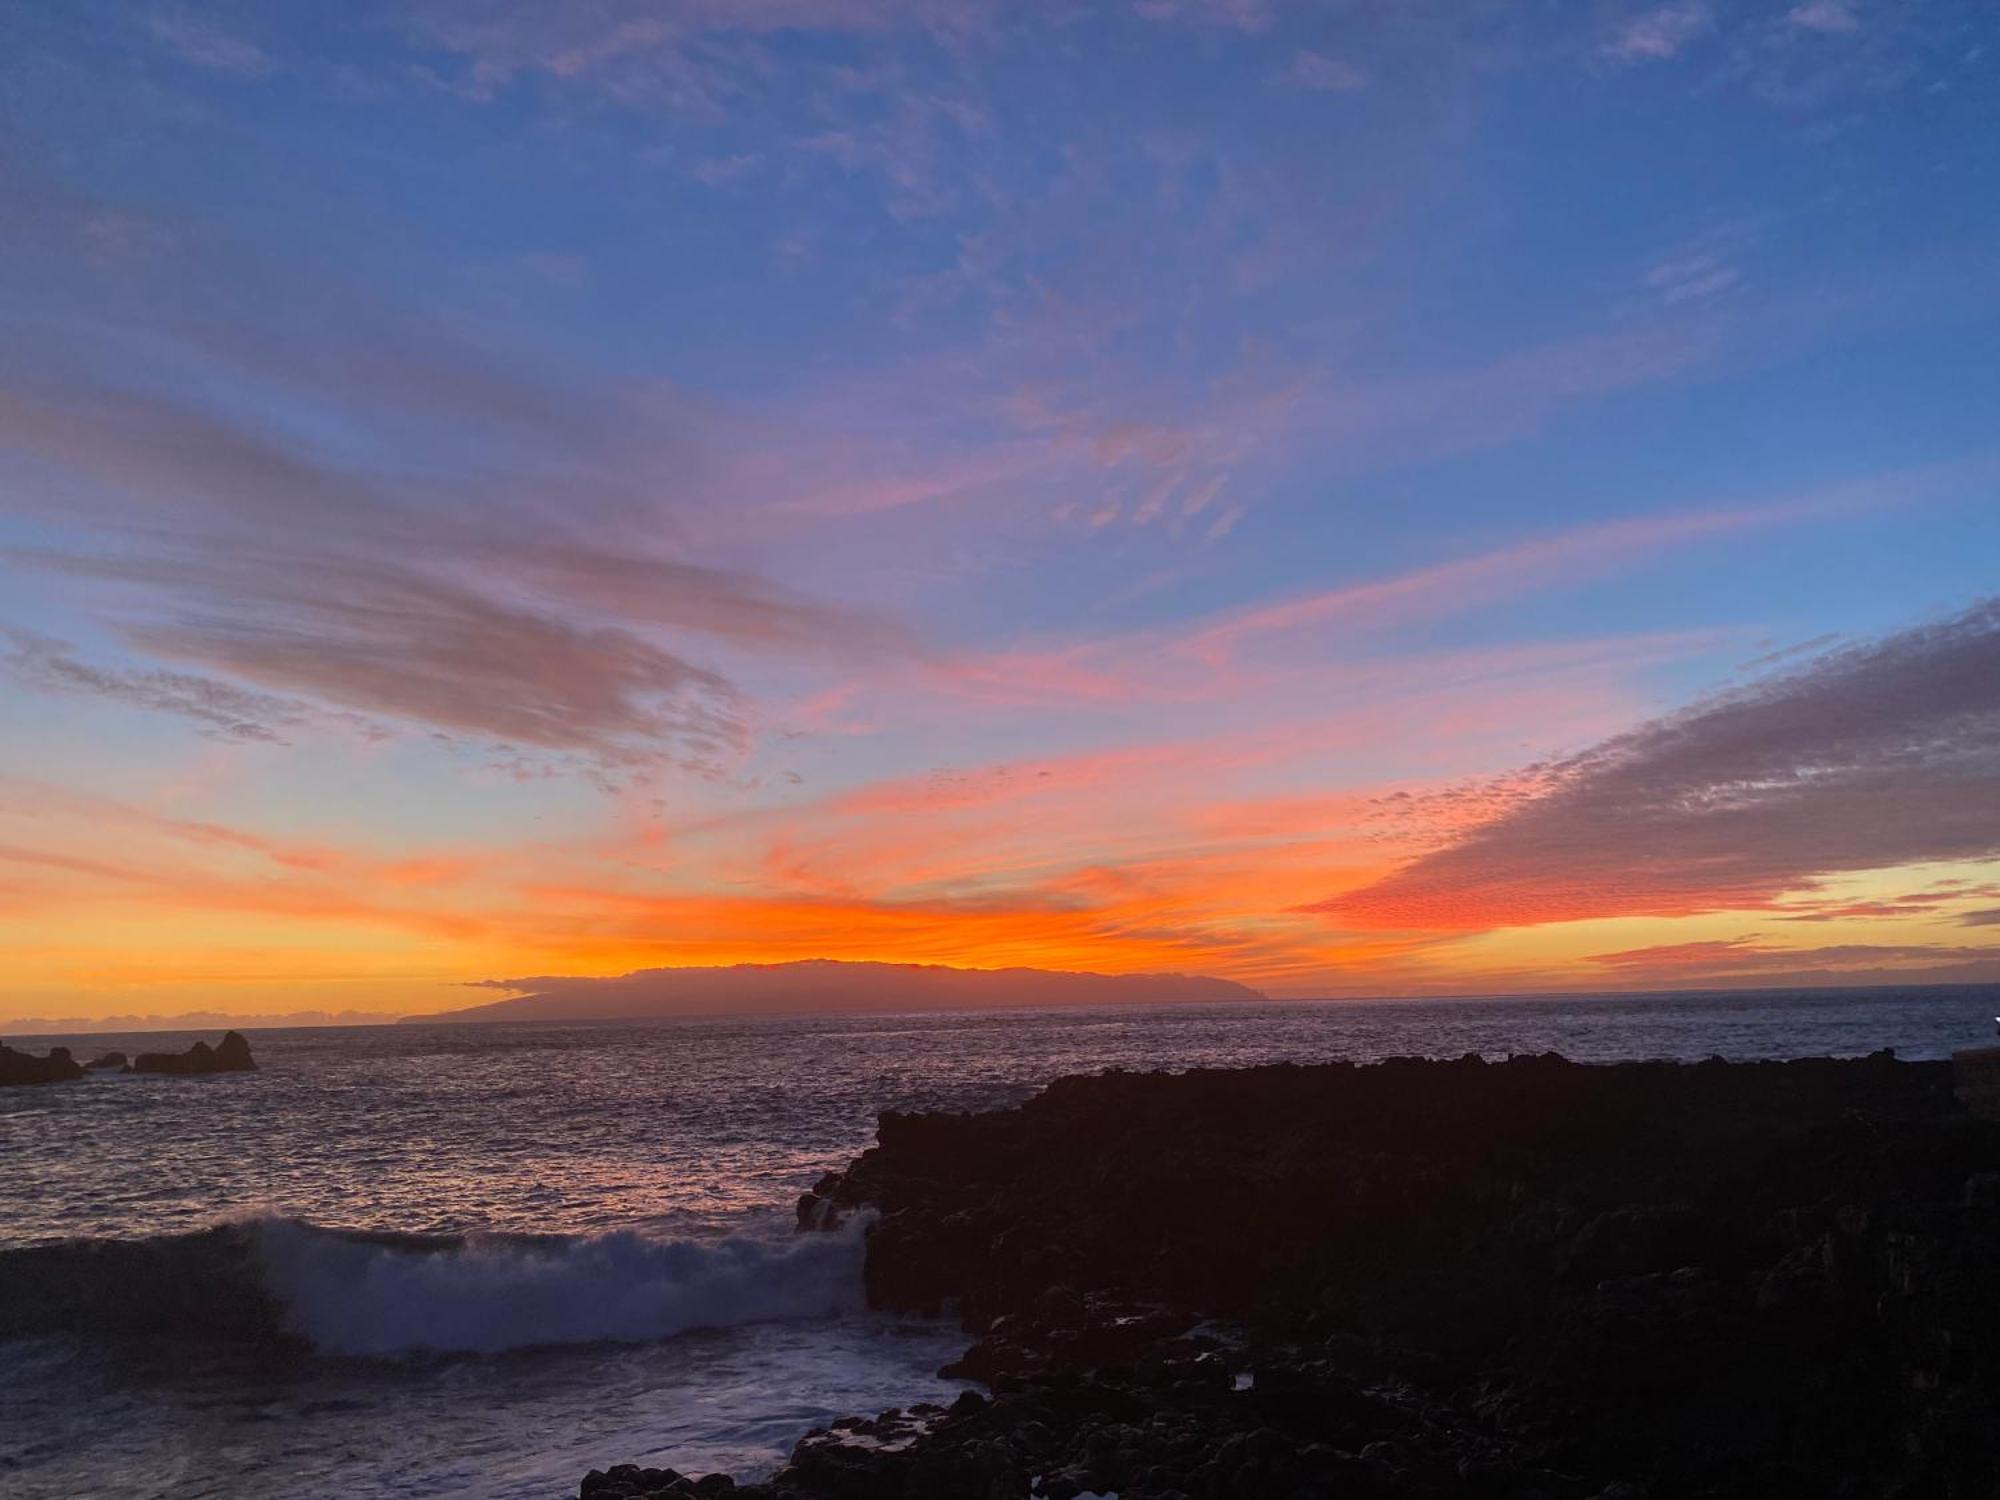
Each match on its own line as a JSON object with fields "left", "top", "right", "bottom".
{"left": 0, "top": 0, "right": 2000, "bottom": 1022}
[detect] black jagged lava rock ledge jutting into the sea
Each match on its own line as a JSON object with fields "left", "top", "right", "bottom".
{"left": 584, "top": 1054, "right": 2000, "bottom": 1500}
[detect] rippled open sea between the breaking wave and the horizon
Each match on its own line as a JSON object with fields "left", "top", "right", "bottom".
{"left": 0, "top": 988, "right": 1994, "bottom": 1244}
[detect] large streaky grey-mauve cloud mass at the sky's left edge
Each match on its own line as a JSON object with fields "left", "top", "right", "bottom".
{"left": 0, "top": 274, "right": 910, "bottom": 778}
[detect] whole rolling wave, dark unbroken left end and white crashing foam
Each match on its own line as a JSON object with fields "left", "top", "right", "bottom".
{"left": 0, "top": 1218, "right": 862, "bottom": 1356}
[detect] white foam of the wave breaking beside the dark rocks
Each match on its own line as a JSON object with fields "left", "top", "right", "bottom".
{"left": 258, "top": 1222, "right": 862, "bottom": 1356}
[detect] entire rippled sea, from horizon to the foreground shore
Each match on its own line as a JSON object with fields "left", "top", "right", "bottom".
{"left": 0, "top": 986, "right": 2000, "bottom": 1500}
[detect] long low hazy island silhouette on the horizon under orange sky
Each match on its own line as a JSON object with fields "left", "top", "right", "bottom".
{"left": 424, "top": 958, "right": 1266, "bottom": 1024}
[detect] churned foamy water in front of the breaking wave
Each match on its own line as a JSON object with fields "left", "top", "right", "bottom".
{"left": 0, "top": 1316, "right": 964, "bottom": 1500}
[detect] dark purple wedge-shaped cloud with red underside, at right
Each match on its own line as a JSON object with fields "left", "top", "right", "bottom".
{"left": 1314, "top": 600, "right": 2000, "bottom": 930}
